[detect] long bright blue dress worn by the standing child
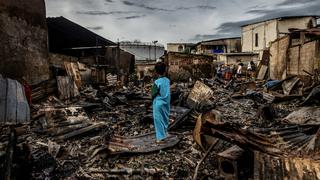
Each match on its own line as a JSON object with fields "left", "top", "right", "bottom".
{"left": 152, "top": 77, "right": 170, "bottom": 141}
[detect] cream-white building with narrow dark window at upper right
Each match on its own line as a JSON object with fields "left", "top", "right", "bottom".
{"left": 241, "top": 16, "right": 318, "bottom": 57}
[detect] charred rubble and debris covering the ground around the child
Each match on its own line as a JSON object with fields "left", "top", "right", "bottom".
{"left": 1, "top": 68, "right": 320, "bottom": 179}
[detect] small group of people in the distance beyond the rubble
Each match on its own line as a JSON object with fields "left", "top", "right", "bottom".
{"left": 216, "top": 61, "right": 256, "bottom": 81}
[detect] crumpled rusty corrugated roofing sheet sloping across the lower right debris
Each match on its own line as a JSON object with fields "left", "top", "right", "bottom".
{"left": 206, "top": 123, "right": 320, "bottom": 159}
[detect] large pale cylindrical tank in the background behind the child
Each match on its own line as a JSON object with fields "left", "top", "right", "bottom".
{"left": 120, "top": 43, "right": 164, "bottom": 63}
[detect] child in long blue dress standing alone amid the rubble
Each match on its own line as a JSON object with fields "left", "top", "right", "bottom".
{"left": 151, "top": 62, "right": 170, "bottom": 143}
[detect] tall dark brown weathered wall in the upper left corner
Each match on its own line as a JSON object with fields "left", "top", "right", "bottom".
{"left": 0, "top": 0, "right": 49, "bottom": 85}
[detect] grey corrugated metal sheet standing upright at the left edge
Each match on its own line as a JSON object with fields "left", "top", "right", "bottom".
{"left": 0, "top": 75, "right": 30, "bottom": 124}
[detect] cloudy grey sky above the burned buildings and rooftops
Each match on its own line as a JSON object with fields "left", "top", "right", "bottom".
{"left": 45, "top": 0, "right": 320, "bottom": 44}
